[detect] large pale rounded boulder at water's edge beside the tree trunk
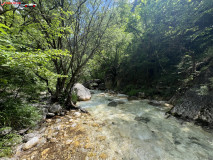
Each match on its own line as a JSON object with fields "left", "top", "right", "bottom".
{"left": 72, "top": 83, "right": 91, "bottom": 101}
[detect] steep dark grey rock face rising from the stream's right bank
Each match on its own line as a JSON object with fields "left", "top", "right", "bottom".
{"left": 170, "top": 60, "right": 213, "bottom": 128}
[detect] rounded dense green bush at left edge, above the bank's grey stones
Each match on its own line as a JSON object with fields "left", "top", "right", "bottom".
{"left": 0, "top": 98, "right": 41, "bottom": 129}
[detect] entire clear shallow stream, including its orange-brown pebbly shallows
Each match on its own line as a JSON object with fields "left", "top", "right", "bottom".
{"left": 16, "top": 92, "right": 213, "bottom": 160}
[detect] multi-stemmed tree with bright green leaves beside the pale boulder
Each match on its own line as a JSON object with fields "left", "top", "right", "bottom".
{"left": 0, "top": 0, "right": 113, "bottom": 105}
